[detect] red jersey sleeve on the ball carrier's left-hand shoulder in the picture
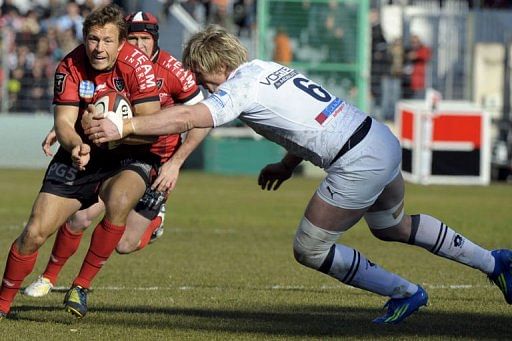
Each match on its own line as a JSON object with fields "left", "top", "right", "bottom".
{"left": 53, "top": 60, "right": 80, "bottom": 106}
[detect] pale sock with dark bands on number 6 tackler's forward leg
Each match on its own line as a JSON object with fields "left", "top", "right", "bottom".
{"left": 322, "top": 244, "right": 418, "bottom": 298}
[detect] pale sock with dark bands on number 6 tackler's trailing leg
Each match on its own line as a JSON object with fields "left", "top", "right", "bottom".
{"left": 409, "top": 214, "right": 494, "bottom": 274}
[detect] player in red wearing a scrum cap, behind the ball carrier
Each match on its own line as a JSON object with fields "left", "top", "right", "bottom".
{"left": 24, "top": 12, "right": 209, "bottom": 308}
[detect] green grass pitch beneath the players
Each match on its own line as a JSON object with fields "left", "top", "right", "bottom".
{"left": 0, "top": 170, "right": 512, "bottom": 340}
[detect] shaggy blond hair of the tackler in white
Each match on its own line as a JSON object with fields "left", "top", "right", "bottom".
{"left": 183, "top": 25, "right": 247, "bottom": 73}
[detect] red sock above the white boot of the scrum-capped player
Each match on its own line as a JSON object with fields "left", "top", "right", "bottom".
{"left": 43, "top": 223, "right": 83, "bottom": 284}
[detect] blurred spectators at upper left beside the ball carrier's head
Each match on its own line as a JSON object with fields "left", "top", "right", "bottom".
{"left": 0, "top": 0, "right": 110, "bottom": 113}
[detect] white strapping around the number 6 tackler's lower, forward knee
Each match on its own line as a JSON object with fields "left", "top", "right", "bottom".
{"left": 293, "top": 217, "right": 341, "bottom": 270}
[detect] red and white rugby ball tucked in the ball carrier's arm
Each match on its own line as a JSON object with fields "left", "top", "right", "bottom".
{"left": 94, "top": 90, "right": 133, "bottom": 149}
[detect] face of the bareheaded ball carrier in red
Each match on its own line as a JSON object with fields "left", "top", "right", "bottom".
{"left": 85, "top": 23, "right": 124, "bottom": 71}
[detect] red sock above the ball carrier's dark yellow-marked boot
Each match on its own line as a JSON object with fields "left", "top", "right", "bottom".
{"left": 73, "top": 218, "right": 126, "bottom": 289}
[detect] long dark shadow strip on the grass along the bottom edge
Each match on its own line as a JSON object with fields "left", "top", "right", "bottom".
{"left": 14, "top": 305, "right": 512, "bottom": 339}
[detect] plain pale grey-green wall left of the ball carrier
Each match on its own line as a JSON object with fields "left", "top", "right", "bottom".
{"left": 0, "top": 114, "right": 53, "bottom": 168}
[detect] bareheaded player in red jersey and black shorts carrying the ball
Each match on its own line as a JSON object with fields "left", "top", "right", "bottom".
{"left": 0, "top": 5, "right": 160, "bottom": 318}
